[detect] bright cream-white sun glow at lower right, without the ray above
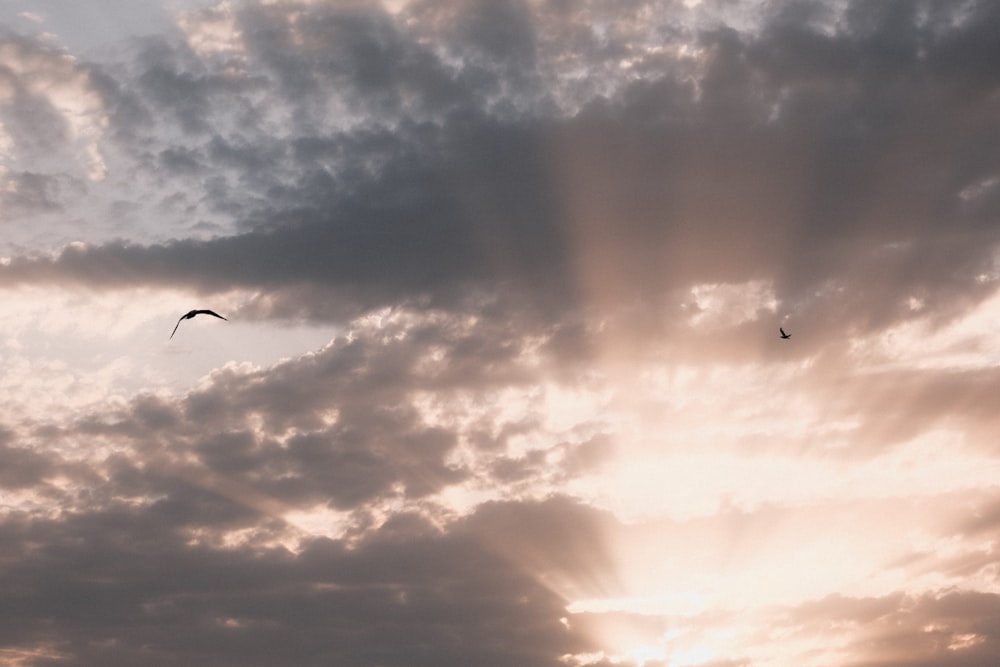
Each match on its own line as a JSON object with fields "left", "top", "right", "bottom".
{"left": 536, "top": 290, "right": 1000, "bottom": 667}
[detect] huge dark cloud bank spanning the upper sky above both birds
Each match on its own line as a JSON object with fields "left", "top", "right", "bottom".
{"left": 3, "top": 3, "right": 1000, "bottom": 352}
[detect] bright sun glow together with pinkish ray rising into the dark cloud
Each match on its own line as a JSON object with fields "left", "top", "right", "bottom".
{"left": 494, "top": 104, "right": 1000, "bottom": 667}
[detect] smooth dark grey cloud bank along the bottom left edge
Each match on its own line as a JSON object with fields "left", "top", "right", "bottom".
{"left": 0, "top": 489, "right": 592, "bottom": 665}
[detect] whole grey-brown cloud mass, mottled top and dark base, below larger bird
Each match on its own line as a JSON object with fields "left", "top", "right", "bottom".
{"left": 0, "top": 319, "right": 610, "bottom": 665}
